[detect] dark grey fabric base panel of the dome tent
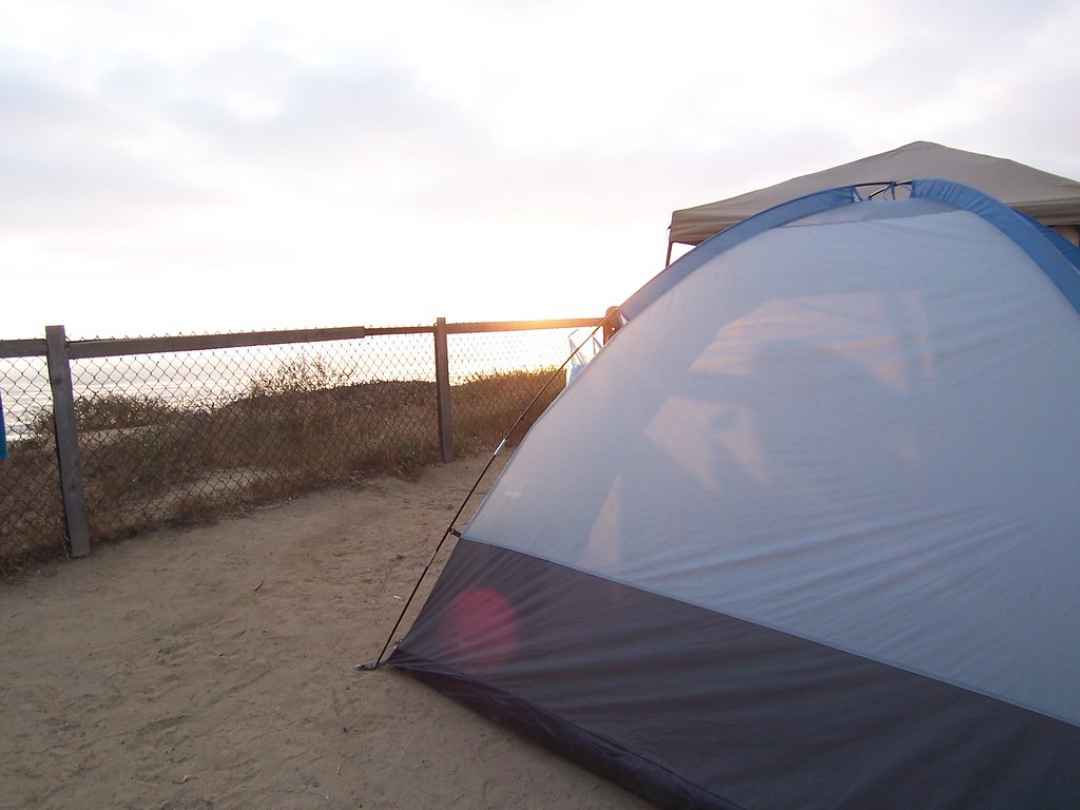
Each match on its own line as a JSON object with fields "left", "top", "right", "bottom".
{"left": 390, "top": 540, "right": 1080, "bottom": 810}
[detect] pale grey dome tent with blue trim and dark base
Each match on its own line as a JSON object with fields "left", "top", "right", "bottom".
{"left": 390, "top": 179, "right": 1080, "bottom": 810}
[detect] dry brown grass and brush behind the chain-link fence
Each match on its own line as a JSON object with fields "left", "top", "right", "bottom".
{"left": 0, "top": 357, "right": 563, "bottom": 573}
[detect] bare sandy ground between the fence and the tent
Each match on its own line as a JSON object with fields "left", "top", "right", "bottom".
{"left": 0, "top": 459, "right": 648, "bottom": 810}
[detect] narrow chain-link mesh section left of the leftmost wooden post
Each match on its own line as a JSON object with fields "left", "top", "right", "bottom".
{"left": 0, "top": 357, "right": 64, "bottom": 573}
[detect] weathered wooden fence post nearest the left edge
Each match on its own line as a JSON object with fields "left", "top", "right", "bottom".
{"left": 45, "top": 326, "right": 90, "bottom": 557}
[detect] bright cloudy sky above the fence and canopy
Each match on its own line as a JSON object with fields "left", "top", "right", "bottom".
{"left": 0, "top": 0, "right": 1080, "bottom": 337}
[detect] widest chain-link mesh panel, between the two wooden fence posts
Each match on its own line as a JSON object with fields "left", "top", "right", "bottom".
{"left": 71, "top": 334, "right": 438, "bottom": 539}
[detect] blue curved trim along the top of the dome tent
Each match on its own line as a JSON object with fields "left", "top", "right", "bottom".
{"left": 620, "top": 178, "right": 1080, "bottom": 321}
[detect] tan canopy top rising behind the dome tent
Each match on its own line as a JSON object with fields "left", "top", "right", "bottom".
{"left": 669, "top": 140, "right": 1080, "bottom": 245}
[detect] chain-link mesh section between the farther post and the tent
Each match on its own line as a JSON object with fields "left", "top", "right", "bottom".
{"left": 446, "top": 328, "right": 593, "bottom": 454}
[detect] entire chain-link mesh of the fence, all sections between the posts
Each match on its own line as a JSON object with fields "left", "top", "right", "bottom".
{"left": 0, "top": 322, "right": 604, "bottom": 567}
